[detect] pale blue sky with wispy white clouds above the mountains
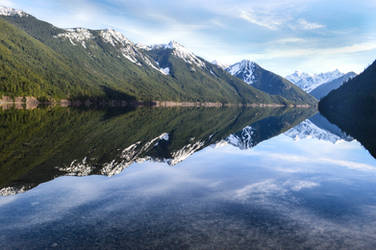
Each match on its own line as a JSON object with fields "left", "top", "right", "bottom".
{"left": 0, "top": 0, "right": 376, "bottom": 76}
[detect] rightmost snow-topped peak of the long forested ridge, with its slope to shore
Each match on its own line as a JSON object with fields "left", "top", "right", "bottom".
{"left": 138, "top": 41, "right": 286, "bottom": 103}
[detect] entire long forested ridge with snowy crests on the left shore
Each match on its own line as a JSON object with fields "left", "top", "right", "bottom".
{"left": 0, "top": 7, "right": 290, "bottom": 104}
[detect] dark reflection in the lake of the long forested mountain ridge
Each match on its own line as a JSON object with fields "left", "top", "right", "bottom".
{"left": 0, "top": 108, "right": 315, "bottom": 195}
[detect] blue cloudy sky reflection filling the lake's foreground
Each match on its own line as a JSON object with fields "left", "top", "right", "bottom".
{"left": 0, "top": 113, "right": 376, "bottom": 249}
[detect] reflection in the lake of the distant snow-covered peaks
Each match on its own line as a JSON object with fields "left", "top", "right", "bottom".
{"left": 284, "top": 119, "right": 344, "bottom": 144}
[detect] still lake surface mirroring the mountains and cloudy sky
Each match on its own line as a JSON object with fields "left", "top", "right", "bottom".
{"left": 0, "top": 108, "right": 376, "bottom": 249}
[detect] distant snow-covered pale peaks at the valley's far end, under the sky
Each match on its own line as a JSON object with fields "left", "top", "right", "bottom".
{"left": 286, "top": 70, "right": 344, "bottom": 93}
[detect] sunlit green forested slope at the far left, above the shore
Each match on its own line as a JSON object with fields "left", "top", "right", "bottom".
{"left": 0, "top": 18, "right": 104, "bottom": 98}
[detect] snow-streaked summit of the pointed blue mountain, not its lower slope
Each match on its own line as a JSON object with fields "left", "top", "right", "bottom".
{"left": 226, "top": 60, "right": 258, "bottom": 84}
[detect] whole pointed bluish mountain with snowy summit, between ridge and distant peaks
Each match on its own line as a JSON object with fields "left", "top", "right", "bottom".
{"left": 226, "top": 60, "right": 317, "bottom": 105}
